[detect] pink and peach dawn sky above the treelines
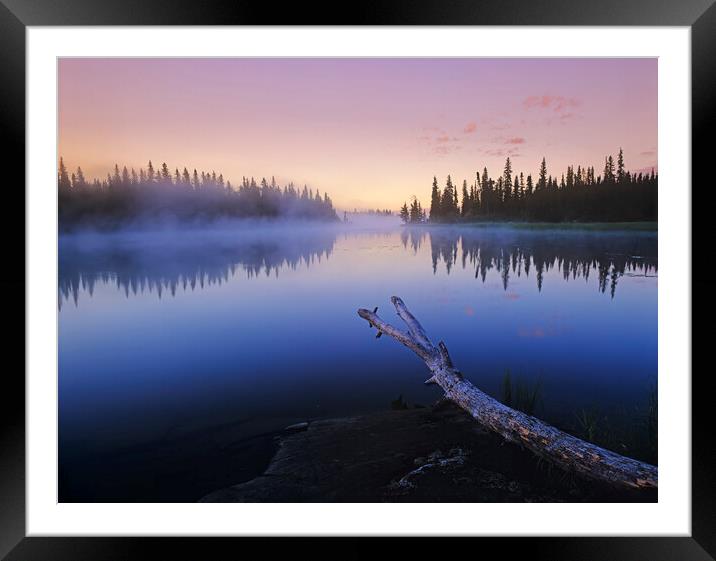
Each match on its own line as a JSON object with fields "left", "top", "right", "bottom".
{"left": 59, "top": 58, "right": 657, "bottom": 209}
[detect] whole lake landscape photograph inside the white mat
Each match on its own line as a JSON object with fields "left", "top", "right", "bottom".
{"left": 57, "top": 56, "right": 660, "bottom": 503}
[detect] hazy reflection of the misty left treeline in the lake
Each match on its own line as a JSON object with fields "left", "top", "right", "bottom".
{"left": 58, "top": 226, "right": 336, "bottom": 309}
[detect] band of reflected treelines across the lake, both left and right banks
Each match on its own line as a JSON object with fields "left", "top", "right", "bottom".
{"left": 58, "top": 228, "right": 657, "bottom": 309}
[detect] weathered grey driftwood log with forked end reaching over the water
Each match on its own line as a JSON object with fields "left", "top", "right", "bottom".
{"left": 358, "top": 296, "right": 657, "bottom": 489}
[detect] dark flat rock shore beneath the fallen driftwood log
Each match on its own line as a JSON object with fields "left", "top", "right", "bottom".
{"left": 199, "top": 402, "right": 657, "bottom": 502}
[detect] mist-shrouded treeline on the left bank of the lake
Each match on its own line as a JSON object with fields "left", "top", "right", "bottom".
{"left": 57, "top": 158, "right": 338, "bottom": 230}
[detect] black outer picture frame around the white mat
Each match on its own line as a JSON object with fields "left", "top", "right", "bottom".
{"left": 0, "top": 0, "right": 716, "bottom": 561}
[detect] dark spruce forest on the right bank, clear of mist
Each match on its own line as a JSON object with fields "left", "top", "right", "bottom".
{"left": 400, "top": 149, "right": 659, "bottom": 224}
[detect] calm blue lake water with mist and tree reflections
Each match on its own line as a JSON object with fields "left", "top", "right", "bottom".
{"left": 59, "top": 226, "right": 658, "bottom": 501}
